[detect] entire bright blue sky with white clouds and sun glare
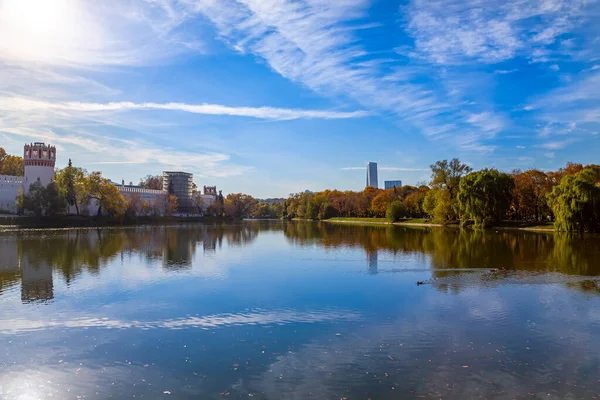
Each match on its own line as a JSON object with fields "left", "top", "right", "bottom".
{"left": 0, "top": 0, "right": 600, "bottom": 197}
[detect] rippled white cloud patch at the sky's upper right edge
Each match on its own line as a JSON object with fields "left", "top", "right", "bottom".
{"left": 403, "top": 0, "right": 589, "bottom": 65}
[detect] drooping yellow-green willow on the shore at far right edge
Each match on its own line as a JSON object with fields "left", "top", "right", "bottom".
{"left": 548, "top": 168, "right": 600, "bottom": 232}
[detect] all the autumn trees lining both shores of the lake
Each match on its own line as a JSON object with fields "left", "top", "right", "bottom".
{"left": 0, "top": 148, "right": 600, "bottom": 232}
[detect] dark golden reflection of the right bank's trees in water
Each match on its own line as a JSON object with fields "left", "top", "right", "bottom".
{"left": 284, "top": 222, "right": 600, "bottom": 278}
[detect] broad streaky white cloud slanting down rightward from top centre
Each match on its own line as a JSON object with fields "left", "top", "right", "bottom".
{"left": 173, "top": 0, "right": 506, "bottom": 152}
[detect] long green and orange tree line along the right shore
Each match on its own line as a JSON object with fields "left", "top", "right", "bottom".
{"left": 284, "top": 158, "right": 600, "bottom": 232}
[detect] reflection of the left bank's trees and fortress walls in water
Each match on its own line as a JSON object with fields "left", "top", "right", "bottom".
{"left": 0, "top": 221, "right": 281, "bottom": 292}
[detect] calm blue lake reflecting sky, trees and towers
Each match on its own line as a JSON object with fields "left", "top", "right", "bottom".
{"left": 0, "top": 221, "right": 600, "bottom": 400}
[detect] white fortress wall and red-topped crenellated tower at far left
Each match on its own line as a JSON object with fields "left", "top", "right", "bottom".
{"left": 0, "top": 142, "right": 56, "bottom": 213}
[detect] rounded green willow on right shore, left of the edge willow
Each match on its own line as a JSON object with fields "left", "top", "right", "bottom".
{"left": 458, "top": 168, "right": 515, "bottom": 227}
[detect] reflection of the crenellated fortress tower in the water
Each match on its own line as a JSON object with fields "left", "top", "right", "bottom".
{"left": 21, "top": 256, "right": 54, "bottom": 303}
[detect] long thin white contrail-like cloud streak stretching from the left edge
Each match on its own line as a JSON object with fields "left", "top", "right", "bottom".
{"left": 0, "top": 97, "right": 367, "bottom": 120}
